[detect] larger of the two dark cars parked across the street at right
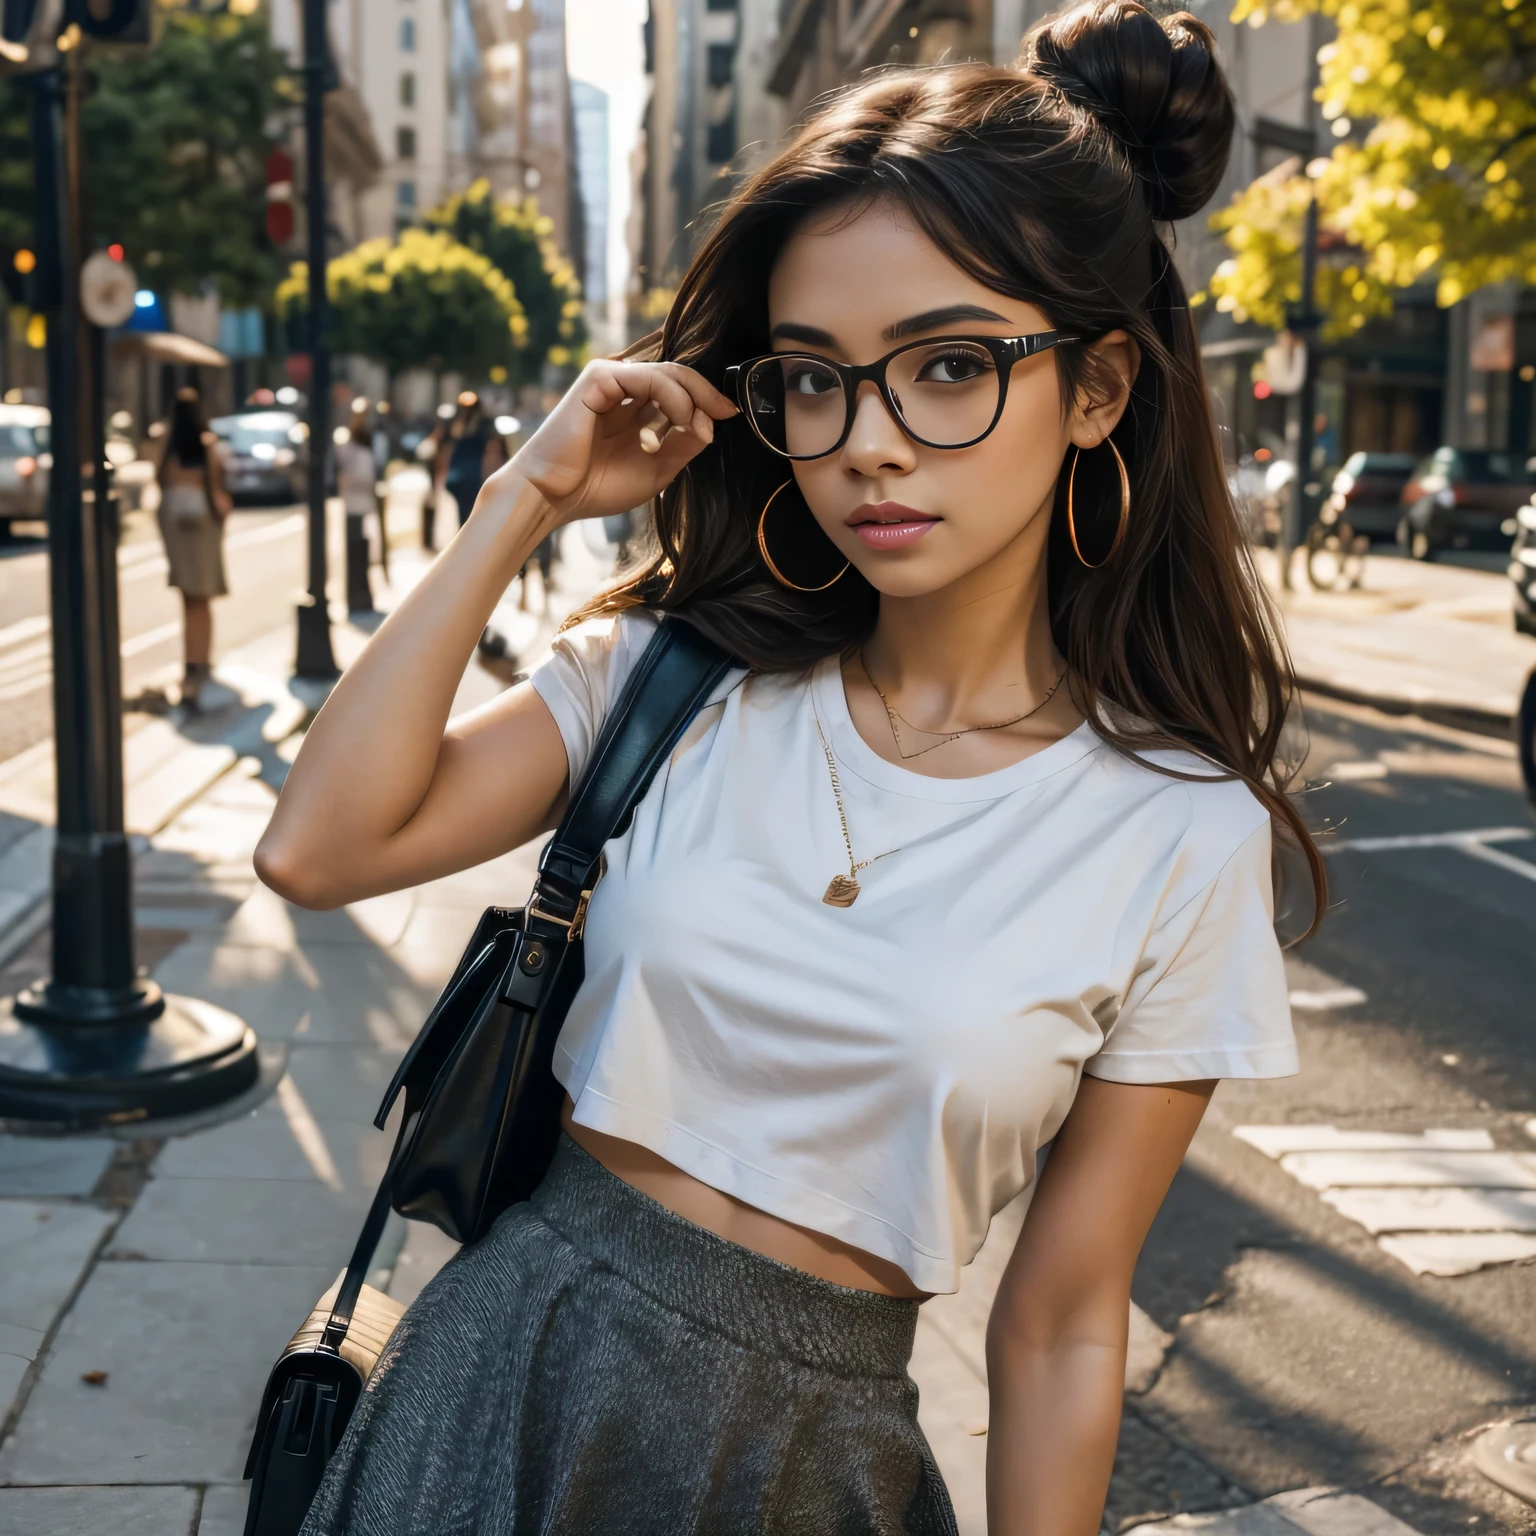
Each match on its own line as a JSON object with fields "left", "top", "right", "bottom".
{"left": 1398, "top": 449, "right": 1536, "bottom": 561}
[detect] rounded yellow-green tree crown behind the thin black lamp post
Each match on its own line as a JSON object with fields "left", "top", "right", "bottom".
{"left": 276, "top": 229, "right": 528, "bottom": 378}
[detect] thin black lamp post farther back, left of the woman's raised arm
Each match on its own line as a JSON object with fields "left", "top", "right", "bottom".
{"left": 293, "top": 0, "right": 339, "bottom": 682}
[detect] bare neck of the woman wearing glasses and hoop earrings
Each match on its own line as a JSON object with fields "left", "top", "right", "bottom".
{"left": 863, "top": 518, "right": 1064, "bottom": 718}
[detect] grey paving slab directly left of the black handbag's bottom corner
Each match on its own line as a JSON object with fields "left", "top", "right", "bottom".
{"left": 109, "top": 1178, "right": 372, "bottom": 1273}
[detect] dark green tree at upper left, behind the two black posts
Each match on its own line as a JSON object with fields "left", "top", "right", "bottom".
{"left": 80, "top": 11, "right": 296, "bottom": 306}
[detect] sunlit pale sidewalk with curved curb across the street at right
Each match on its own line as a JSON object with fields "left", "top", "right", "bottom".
{"left": 1256, "top": 550, "right": 1536, "bottom": 736}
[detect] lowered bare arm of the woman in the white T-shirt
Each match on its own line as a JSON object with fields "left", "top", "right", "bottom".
{"left": 986, "top": 1077, "right": 1215, "bottom": 1536}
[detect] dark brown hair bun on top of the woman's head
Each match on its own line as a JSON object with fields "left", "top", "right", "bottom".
{"left": 1025, "top": 0, "right": 1235, "bottom": 220}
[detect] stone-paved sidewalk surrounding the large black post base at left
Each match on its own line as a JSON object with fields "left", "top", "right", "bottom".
{"left": 0, "top": 522, "right": 602, "bottom": 1536}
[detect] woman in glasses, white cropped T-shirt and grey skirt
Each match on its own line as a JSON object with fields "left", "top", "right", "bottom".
{"left": 258, "top": 0, "right": 1321, "bottom": 1536}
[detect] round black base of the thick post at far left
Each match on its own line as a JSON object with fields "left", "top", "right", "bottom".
{"left": 0, "top": 980, "right": 260, "bottom": 1129}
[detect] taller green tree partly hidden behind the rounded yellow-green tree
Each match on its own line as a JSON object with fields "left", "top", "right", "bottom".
{"left": 425, "top": 180, "right": 587, "bottom": 382}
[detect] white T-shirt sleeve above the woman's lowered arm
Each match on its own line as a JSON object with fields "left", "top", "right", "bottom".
{"left": 1083, "top": 819, "right": 1298, "bottom": 1083}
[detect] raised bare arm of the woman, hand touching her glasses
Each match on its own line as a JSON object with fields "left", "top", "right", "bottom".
{"left": 255, "top": 362, "right": 734, "bottom": 906}
